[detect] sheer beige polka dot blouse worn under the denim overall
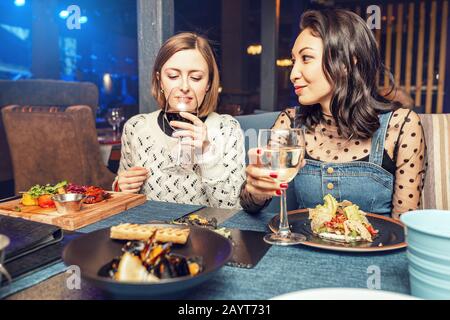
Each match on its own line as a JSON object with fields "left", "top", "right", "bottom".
{"left": 274, "top": 108, "right": 426, "bottom": 215}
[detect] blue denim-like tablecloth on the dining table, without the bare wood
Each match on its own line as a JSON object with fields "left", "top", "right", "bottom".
{"left": 0, "top": 202, "right": 410, "bottom": 300}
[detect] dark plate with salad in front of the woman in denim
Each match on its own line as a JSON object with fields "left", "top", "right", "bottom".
{"left": 269, "top": 195, "right": 407, "bottom": 252}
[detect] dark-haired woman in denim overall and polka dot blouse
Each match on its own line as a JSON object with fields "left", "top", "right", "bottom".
{"left": 241, "top": 10, "right": 425, "bottom": 218}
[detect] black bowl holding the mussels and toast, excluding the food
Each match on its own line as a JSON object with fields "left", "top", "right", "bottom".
{"left": 63, "top": 225, "right": 232, "bottom": 298}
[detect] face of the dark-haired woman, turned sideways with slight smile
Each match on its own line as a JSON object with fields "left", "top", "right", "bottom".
{"left": 290, "top": 29, "right": 332, "bottom": 110}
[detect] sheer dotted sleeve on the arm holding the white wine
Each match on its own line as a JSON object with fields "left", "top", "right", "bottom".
{"left": 240, "top": 108, "right": 295, "bottom": 213}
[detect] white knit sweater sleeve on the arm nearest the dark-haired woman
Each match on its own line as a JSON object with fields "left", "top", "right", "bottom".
{"left": 197, "top": 115, "right": 245, "bottom": 208}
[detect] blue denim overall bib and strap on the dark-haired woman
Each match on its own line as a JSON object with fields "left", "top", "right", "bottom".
{"left": 294, "top": 112, "right": 394, "bottom": 214}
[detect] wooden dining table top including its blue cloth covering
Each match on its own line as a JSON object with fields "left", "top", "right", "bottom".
{"left": 0, "top": 201, "right": 410, "bottom": 300}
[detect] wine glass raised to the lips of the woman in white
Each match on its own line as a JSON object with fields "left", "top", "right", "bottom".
{"left": 163, "top": 87, "right": 198, "bottom": 170}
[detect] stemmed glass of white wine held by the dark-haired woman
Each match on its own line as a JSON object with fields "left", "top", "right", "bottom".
{"left": 258, "top": 128, "right": 306, "bottom": 245}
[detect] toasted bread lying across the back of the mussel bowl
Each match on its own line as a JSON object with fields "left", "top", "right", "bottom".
{"left": 110, "top": 223, "right": 190, "bottom": 244}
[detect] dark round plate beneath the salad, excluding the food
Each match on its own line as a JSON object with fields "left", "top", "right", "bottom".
{"left": 269, "top": 209, "right": 406, "bottom": 252}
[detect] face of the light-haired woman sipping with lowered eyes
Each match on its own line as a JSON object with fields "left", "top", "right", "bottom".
{"left": 160, "top": 49, "right": 209, "bottom": 111}
